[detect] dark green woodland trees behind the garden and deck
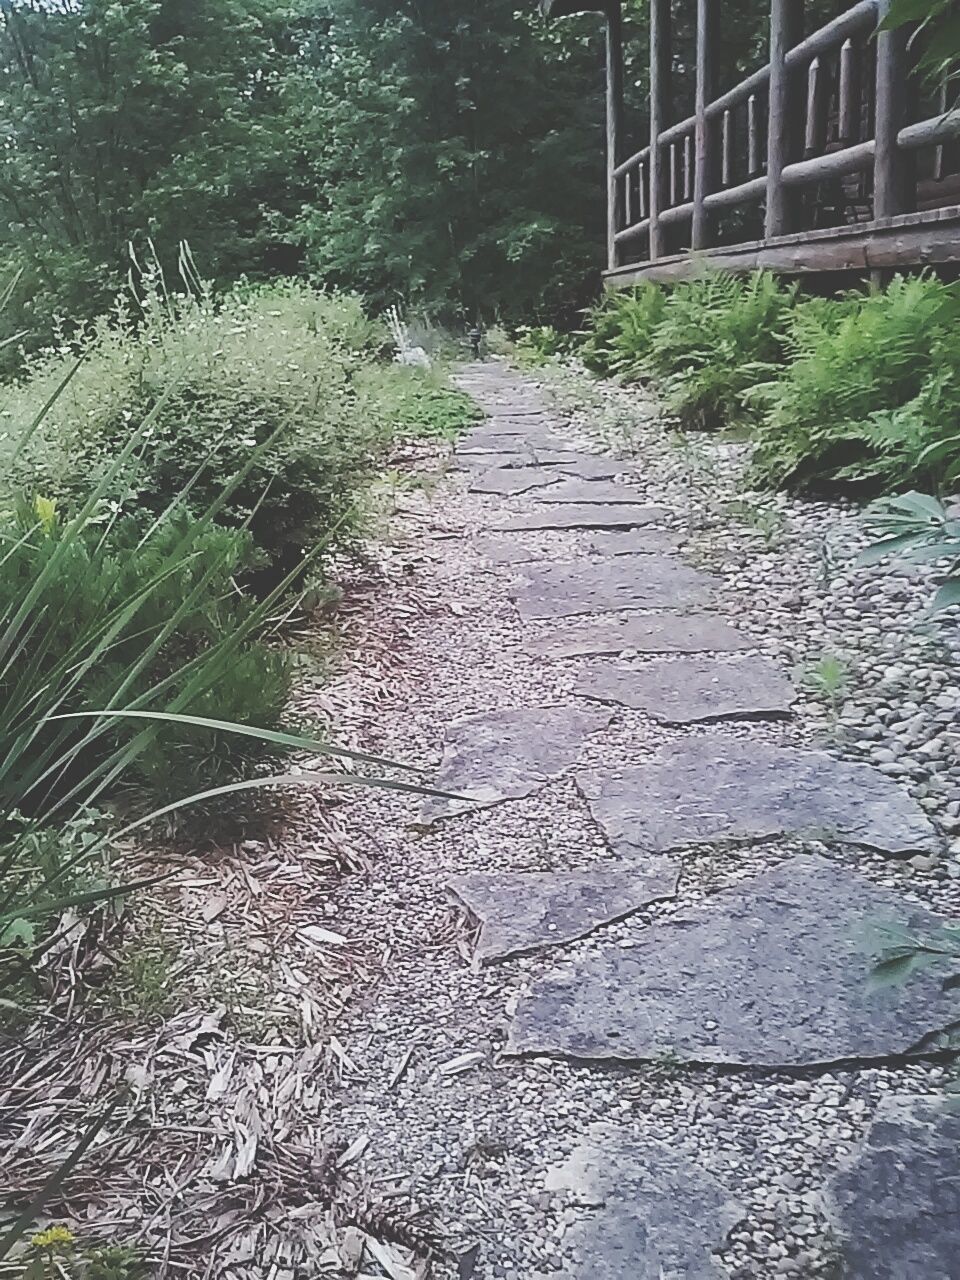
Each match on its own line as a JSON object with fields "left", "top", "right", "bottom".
{"left": 0, "top": 0, "right": 836, "bottom": 355}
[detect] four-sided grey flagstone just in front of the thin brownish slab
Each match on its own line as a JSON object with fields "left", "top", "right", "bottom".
{"left": 576, "top": 657, "right": 795, "bottom": 724}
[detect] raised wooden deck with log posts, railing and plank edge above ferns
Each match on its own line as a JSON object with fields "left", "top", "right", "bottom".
{"left": 541, "top": 0, "right": 960, "bottom": 287}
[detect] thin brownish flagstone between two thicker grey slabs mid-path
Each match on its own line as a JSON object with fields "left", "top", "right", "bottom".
{"left": 524, "top": 613, "right": 753, "bottom": 658}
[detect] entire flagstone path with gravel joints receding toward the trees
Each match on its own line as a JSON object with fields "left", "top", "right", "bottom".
{"left": 325, "top": 362, "right": 960, "bottom": 1280}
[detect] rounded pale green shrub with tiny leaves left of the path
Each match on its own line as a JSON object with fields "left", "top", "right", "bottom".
{"left": 0, "top": 280, "right": 389, "bottom": 586}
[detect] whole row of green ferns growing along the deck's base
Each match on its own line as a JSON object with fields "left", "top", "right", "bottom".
{"left": 582, "top": 273, "right": 960, "bottom": 493}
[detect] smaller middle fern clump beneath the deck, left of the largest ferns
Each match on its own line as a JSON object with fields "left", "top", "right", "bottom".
{"left": 644, "top": 271, "right": 796, "bottom": 430}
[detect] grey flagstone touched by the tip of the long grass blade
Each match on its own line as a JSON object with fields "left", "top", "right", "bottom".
{"left": 421, "top": 707, "right": 611, "bottom": 822}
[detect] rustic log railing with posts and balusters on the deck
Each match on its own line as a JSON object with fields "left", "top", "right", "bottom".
{"left": 608, "top": 0, "right": 960, "bottom": 277}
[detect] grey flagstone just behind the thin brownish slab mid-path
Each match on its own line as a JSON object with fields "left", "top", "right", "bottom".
{"left": 511, "top": 556, "right": 717, "bottom": 621}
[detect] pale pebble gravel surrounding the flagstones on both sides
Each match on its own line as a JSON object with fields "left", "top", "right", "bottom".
{"left": 309, "top": 360, "right": 960, "bottom": 1280}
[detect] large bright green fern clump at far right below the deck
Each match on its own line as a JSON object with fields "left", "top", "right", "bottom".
{"left": 750, "top": 275, "right": 960, "bottom": 492}
